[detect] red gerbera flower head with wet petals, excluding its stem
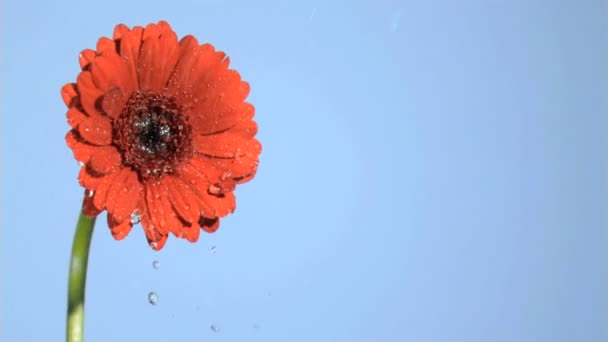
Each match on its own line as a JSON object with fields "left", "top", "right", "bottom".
{"left": 61, "top": 21, "right": 261, "bottom": 250}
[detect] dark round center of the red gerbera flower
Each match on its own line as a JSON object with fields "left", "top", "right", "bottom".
{"left": 114, "top": 91, "right": 192, "bottom": 179}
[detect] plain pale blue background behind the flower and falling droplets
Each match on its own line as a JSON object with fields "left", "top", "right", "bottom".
{"left": 1, "top": 0, "right": 608, "bottom": 342}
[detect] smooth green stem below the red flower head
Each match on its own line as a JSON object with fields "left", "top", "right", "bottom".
{"left": 67, "top": 213, "right": 95, "bottom": 342}
